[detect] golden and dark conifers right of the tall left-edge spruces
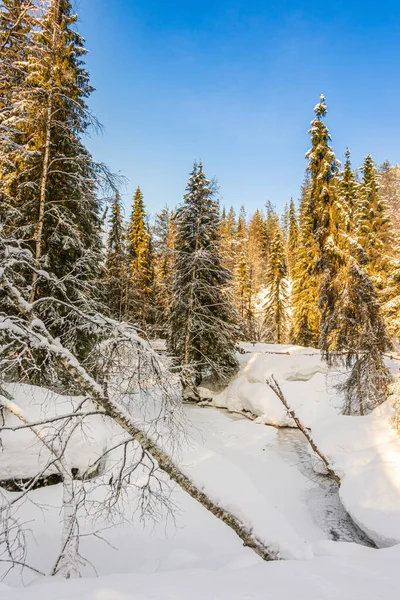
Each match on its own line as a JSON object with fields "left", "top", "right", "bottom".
{"left": 106, "top": 97, "right": 400, "bottom": 414}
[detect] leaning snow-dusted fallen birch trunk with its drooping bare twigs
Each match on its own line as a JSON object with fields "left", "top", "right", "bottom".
{"left": 0, "top": 234, "right": 275, "bottom": 573}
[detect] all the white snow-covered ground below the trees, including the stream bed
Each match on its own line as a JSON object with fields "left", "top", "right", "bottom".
{"left": 0, "top": 345, "right": 400, "bottom": 600}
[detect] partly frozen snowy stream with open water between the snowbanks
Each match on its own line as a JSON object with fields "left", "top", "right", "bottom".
{"left": 186, "top": 406, "right": 373, "bottom": 546}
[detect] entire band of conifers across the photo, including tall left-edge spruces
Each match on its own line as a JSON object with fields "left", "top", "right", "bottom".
{"left": 0, "top": 0, "right": 400, "bottom": 420}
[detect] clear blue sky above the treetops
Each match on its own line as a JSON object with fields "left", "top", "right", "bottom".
{"left": 77, "top": 0, "right": 400, "bottom": 220}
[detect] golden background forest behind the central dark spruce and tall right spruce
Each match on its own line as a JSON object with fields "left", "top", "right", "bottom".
{"left": 106, "top": 110, "right": 400, "bottom": 354}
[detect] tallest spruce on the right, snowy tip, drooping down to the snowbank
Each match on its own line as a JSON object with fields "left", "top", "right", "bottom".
{"left": 309, "top": 110, "right": 390, "bottom": 415}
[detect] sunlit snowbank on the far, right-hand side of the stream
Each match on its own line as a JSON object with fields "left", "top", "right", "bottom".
{"left": 213, "top": 344, "right": 400, "bottom": 547}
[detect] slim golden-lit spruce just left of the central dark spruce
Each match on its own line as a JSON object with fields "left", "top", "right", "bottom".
{"left": 128, "top": 187, "right": 154, "bottom": 329}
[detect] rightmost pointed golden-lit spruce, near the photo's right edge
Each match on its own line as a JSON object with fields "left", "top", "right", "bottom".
{"left": 357, "top": 154, "right": 392, "bottom": 291}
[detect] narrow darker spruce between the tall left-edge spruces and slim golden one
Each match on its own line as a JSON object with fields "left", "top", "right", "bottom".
{"left": 105, "top": 192, "right": 128, "bottom": 320}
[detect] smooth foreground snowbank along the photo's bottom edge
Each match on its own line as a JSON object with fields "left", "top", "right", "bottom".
{"left": 0, "top": 548, "right": 400, "bottom": 600}
